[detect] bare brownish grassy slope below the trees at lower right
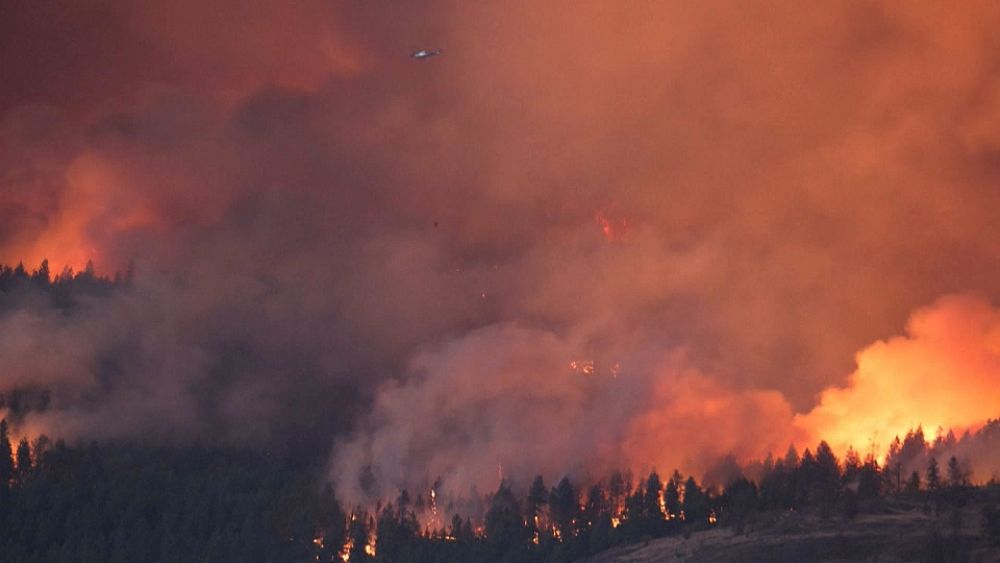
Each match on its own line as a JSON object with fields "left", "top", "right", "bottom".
{"left": 584, "top": 487, "right": 1000, "bottom": 563}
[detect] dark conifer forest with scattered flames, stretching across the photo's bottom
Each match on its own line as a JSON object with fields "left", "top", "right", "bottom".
{"left": 0, "top": 420, "right": 1000, "bottom": 562}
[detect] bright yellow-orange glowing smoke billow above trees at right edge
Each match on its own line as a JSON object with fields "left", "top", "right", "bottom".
{"left": 795, "top": 297, "right": 1000, "bottom": 455}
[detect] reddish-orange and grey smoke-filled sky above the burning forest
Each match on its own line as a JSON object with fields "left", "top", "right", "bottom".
{"left": 0, "top": 0, "right": 1000, "bottom": 494}
